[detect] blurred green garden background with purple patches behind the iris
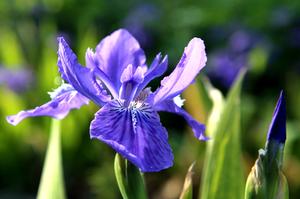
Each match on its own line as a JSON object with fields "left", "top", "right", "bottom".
{"left": 0, "top": 0, "right": 300, "bottom": 199}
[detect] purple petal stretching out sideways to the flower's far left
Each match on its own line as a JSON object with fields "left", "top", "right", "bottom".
{"left": 6, "top": 84, "right": 89, "bottom": 125}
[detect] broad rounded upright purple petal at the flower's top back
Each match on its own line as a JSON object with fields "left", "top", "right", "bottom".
{"left": 93, "top": 29, "right": 146, "bottom": 90}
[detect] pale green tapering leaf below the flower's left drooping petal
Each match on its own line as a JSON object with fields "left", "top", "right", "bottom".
{"left": 37, "top": 119, "right": 66, "bottom": 199}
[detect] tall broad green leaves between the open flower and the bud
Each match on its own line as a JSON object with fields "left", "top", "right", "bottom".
{"left": 200, "top": 71, "right": 245, "bottom": 199}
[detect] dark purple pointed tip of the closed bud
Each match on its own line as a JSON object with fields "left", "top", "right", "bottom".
{"left": 268, "top": 91, "right": 286, "bottom": 144}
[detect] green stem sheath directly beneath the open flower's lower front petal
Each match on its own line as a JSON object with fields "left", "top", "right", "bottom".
{"left": 114, "top": 153, "right": 147, "bottom": 199}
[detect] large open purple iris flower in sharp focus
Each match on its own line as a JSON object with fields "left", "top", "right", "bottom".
{"left": 7, "top": 29, "right": 207, "bottom": 172}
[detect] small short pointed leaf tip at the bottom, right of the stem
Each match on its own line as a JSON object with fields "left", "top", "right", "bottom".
{"left": 179, "top": 162, "right": 195, "bottom": 199}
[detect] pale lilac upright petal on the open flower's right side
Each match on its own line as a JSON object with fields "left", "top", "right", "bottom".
{"left": 152, "top": 38, "right": 207, "bottom": 105}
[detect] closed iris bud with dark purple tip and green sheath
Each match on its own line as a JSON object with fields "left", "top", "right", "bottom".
{"left": 245, "top": 92, "right": 289, "bottom": 199}
